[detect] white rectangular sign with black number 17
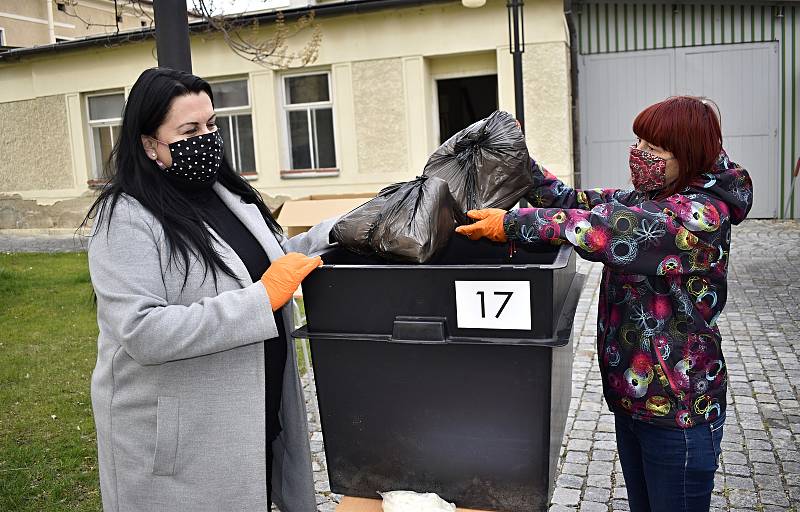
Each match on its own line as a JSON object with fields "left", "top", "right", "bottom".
{"left": 455, "top": 281, "right": 531, "bottom": 331}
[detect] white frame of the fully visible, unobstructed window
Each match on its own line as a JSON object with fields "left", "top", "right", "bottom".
{"left": 281, "top": 70, "right": 339, "bottom": 179}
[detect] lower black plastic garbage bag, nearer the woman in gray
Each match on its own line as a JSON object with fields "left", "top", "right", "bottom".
{"left": 333, "top": 176, "right": 466, "bottom": 263}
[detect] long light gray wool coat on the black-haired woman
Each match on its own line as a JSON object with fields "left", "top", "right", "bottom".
{"left": 89, "top": 184, "right": 333, "bottom": 512}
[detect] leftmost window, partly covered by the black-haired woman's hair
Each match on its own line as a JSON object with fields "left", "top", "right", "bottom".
{"left": 86, "top": 93, "right": 125, "bottom": 179}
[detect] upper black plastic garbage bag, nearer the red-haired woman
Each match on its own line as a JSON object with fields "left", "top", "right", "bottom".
{"left": 423, "top": 110, "right": 533, "bottom": 211}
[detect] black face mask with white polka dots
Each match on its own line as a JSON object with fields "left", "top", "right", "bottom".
{"left": 153, "top": 131, "right": 222, "bottom": 185}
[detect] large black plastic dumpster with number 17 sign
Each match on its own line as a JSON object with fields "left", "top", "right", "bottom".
{"left": 295, "top": 237, "right": 583, "bottom": 512}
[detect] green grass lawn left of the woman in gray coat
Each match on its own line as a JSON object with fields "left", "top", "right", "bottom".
{"left": 0, "top": 253, "right": 305, "bottom": 512}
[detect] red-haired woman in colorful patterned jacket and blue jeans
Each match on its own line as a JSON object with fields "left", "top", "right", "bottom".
{"left": 457, "top": 96, "right": 753, "bottom": 512}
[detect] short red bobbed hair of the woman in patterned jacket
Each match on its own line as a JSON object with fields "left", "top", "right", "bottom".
{"left": 633, "top": 96, "right": 722, "bottom": 196}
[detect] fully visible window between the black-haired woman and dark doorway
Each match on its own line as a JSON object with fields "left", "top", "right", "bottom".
{"left": 282, "top": 73, "right": 338, "bottom": 177}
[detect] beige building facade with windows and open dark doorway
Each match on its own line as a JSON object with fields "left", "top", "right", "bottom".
{"left": 0, "top": 0, "right": 573, "bottom": 226}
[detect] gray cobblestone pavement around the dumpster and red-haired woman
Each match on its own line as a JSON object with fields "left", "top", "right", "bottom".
{"left": 304, "top": 221, "right": 800, "bottom": 512}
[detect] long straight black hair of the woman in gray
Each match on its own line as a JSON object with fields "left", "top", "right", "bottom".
{"left": 81, "top": 68, "right": 282, "bottom": 286}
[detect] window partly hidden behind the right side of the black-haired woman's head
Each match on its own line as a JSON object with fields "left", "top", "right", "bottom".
{"left": 211, "top": 80, "right": 256, "bottom": 175}
